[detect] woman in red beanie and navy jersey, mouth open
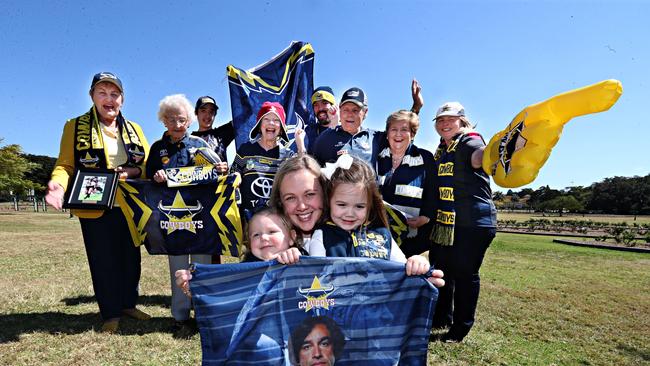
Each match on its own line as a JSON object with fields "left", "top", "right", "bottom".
{"left": 230, "top": 102, "right": 305, "bottom": 221}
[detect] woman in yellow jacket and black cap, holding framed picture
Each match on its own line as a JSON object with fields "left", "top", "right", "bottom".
{"left": 45, "top": 72, "right": 150, "bottom": 333}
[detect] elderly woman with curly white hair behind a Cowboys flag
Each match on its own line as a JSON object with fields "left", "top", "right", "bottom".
{"left": 147, "top": 94, "right": 212, "bottom": 338}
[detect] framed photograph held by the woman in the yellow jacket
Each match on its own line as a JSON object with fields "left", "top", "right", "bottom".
{"left": 63, "top": 169, "right": 118, "bottom": 210}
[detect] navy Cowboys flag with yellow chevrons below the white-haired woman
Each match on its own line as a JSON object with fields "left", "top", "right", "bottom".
{"left": 115, "top": 175, "right": 242, "bottom": 257}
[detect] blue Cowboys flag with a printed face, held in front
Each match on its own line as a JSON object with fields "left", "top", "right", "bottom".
{"left": 190, "top": 257, "right": 438, "bottom": 366}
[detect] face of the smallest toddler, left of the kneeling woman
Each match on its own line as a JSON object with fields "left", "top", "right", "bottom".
{"left": 248, "top": 213, "right": 294, "bottom": 261}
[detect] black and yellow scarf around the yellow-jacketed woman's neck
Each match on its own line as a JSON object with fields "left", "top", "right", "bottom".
{"left": 74, "top": 106, "right": 145, "bottom": 169}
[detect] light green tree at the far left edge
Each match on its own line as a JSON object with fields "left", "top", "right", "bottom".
{"left": 0, "top": 138, "right": 42, "bottom": 194}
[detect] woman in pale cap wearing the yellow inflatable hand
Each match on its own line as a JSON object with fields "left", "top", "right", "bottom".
{"left": 429, "top": 102, "right": 496, "bottom": 342}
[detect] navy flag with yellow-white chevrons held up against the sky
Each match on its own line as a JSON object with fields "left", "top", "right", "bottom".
{"left": 226, "top": 42, "right": 316, "bottom": 151}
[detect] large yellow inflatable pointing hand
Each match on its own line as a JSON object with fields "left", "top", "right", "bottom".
{"left": 483, "top": 79, "right": 623, "bottom": 188}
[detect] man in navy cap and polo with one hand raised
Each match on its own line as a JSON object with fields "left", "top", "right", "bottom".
{"left": 310, "top": 79, "right": 423, "bottom": 168}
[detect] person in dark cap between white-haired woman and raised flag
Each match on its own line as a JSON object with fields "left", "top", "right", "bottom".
{"left": 192, "top": 95, "right": 235, "bottom": 173}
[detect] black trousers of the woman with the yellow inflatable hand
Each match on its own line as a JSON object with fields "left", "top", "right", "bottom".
{"left": 429, "top": 227, "right": 496, "bottom": 341}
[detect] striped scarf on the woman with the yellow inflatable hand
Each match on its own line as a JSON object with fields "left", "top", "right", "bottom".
{"left": 430, "top": 134, "right": 463, "bottom": 246}
